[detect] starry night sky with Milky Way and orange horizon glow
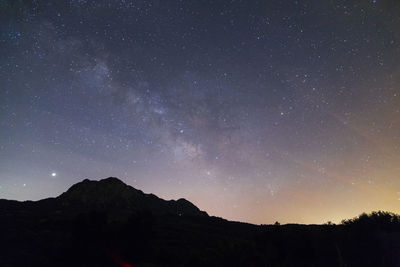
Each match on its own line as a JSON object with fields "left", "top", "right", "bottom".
{"left": 0, "top": 0, "right": 400, "bottom": 223}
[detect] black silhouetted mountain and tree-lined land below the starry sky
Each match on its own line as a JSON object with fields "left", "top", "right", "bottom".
{"left": 0, "top": 178, "right": 400, "bottom": 267}
